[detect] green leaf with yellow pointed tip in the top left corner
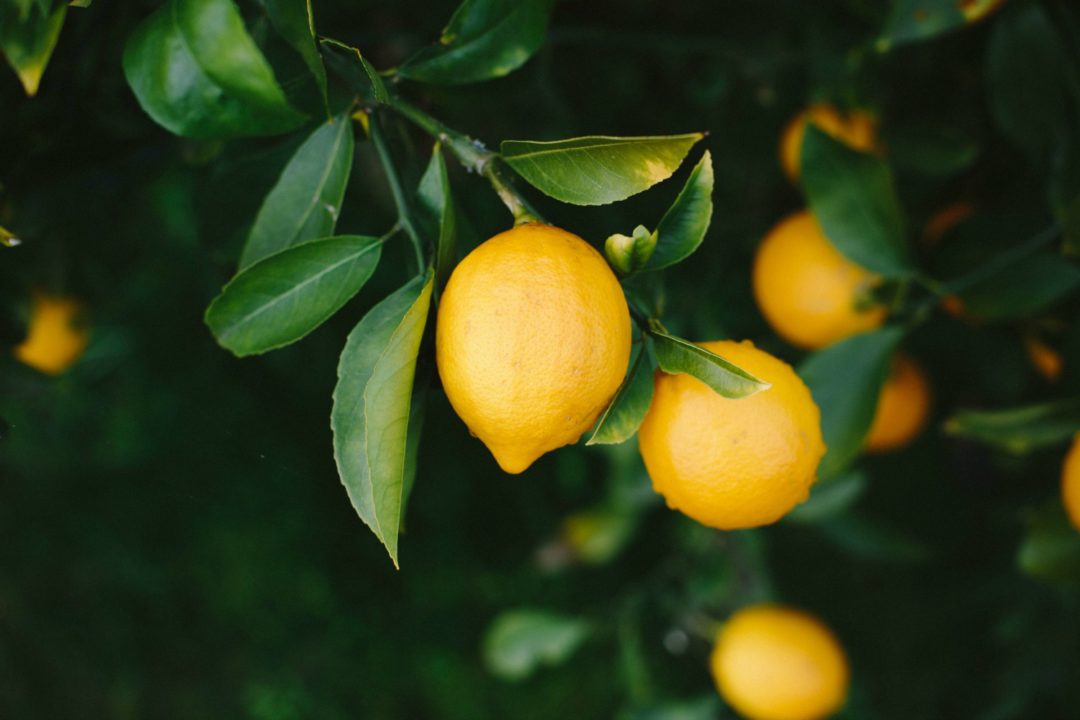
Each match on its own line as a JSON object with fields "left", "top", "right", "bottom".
{"left": 0, "top": 2, "right": 67, "bottom": 97}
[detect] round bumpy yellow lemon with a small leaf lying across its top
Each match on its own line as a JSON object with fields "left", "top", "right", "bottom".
{"left": 638, "top": 340, "right": 825, "bottom": 530}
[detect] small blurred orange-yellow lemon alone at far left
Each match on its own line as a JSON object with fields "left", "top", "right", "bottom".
{"left": 15, "top": 295, "right": 90, "bottom": 375}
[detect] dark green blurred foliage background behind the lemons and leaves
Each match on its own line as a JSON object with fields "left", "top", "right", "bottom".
{"left": 0, "top": 0, "right": 1080, "bottom": 720}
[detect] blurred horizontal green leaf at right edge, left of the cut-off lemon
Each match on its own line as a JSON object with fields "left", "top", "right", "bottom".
{"left": 945, "top": 397, "right": 1080, "bottom": 454}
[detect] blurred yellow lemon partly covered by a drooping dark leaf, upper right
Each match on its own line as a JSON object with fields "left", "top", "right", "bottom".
{"left": 753, "top": 212, "right": 886, "bottom": 349}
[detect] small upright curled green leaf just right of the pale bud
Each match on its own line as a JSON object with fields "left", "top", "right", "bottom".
{"left": 646, "top": 150, "right": 713, "bottom": 270}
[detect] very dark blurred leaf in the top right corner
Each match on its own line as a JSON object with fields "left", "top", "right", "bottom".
{"left": 986, "top": 2, "right": 1080, "bottom": 160}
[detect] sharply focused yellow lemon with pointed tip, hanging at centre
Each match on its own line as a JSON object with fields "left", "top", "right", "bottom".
{"left": 435, "top": 223, "right": 631, "bottom": 473}
